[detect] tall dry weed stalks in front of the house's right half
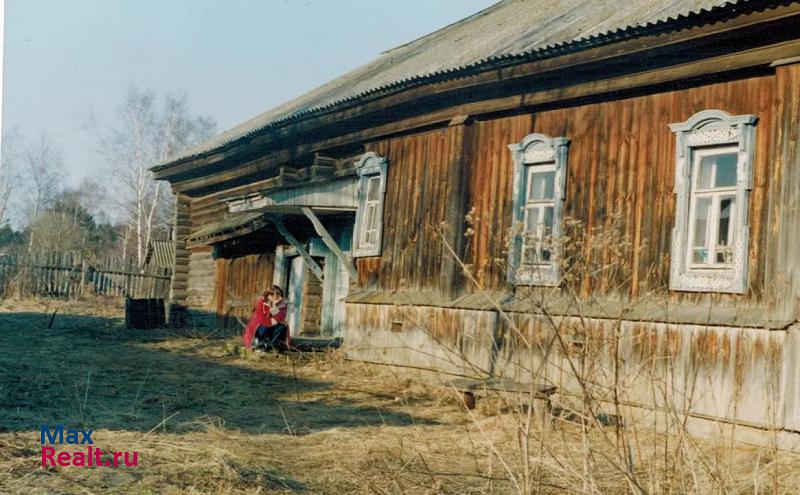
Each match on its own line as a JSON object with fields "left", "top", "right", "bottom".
{"left": 370, "top": 209, "right": 792, "bottom": 494}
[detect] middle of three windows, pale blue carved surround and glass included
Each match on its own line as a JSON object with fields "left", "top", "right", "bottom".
{"left": 508, "top": 134, "right": 569, "bottom": 285}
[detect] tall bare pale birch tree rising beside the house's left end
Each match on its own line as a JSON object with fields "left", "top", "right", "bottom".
{"left": 95, "top": 88, "right": 216, "bottom": 263}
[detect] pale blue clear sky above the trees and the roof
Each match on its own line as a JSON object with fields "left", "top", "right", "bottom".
{"left": 2, "top": 0, "right": 495, "bottom": 185}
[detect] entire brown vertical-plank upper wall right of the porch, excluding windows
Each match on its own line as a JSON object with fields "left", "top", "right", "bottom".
{"left": 358, "top": 70, "right": 800, "bottom": 317}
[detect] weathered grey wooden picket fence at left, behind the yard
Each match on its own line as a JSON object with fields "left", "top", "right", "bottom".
{"left": 0, "top": 253, "right": 171, "bottom": 299}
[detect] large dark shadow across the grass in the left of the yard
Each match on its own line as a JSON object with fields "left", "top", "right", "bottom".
{"left": 0, "top": 313, "right": 432, "bottom": 434}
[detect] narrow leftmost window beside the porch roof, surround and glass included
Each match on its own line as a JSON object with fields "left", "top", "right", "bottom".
{"left": 353, "top": 152, "right": 387, "bottom": 257}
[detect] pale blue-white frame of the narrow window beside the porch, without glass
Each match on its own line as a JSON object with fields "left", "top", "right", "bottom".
{"left": 352, "top": 151, "right": 388, "bottom": 258}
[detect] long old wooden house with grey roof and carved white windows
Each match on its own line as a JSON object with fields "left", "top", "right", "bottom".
{"left": 153, "top": 0, "right": 800, "bottom": 448}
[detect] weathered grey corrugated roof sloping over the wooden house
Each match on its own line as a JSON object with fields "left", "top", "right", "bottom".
{"left": 155, "top": 0, "right": 774, "bottom": 169}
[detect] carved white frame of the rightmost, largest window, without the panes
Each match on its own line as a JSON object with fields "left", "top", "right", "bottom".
{"left": 670, "top": 110, "right": 758, "bottom": 294}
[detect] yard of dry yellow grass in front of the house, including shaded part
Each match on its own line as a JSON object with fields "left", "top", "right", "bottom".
{"left": 0, "top": 300, "right": 800, "bottom": 494}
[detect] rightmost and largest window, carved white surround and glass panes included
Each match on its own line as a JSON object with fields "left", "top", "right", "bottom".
{"left": 670, "top": 110, "right": 756, "bottom": 293}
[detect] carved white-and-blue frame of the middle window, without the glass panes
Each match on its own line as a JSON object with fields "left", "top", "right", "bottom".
{"left": 508, "top": 134, "right": 569, "bottom": 286}
